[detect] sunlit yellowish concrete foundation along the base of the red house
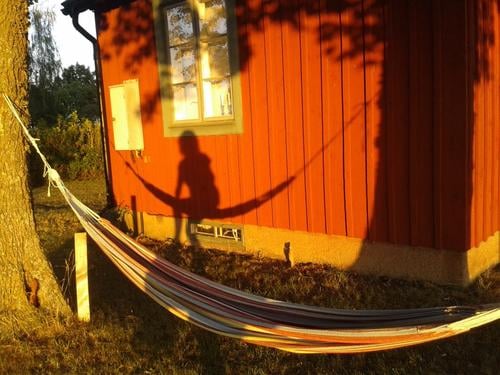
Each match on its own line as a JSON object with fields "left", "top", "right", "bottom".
{"left": 124, "top": 212, "right": 500, "bottom": 285}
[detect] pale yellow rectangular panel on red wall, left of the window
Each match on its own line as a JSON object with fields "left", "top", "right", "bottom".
{"left": 109, "top": 79, "right": 144, "bottom": 151}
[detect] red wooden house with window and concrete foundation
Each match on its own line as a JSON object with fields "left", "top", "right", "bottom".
{"left": 63, "top": 0, "right": 500, "bottom": 283}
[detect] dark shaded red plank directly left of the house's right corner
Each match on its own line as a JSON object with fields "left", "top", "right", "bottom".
{"left": 433, "top": 1, "right": 470, "bottom": 250}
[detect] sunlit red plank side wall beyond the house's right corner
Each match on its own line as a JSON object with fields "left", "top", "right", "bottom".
{"left": 470, "top": 0, "right": 500, "bottom": 246}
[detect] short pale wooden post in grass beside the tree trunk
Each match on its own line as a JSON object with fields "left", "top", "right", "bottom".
{"left": 75, "top": 232, "right": 90, "bottom": 322}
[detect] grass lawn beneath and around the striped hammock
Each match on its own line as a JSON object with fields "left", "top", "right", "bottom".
{"left": 0, "top": 181, "right": 500, "bottom": 374}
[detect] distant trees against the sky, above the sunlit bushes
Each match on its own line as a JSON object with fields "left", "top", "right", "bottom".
{"left": 29, "top": 6, "right": 99, "bottom": 126}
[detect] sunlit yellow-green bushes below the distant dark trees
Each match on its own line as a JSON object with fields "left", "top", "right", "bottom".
{"left": 30, "top": 112, "right": 103, "bottom": 185}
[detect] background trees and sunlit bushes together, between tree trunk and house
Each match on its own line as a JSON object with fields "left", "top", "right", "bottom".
{"left": 28, "top": 5, "right": 103, "bottom": 182}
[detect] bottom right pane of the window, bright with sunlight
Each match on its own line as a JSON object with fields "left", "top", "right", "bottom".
{"left": 203, "top": 78, "right": 233, "bottom": 118}
